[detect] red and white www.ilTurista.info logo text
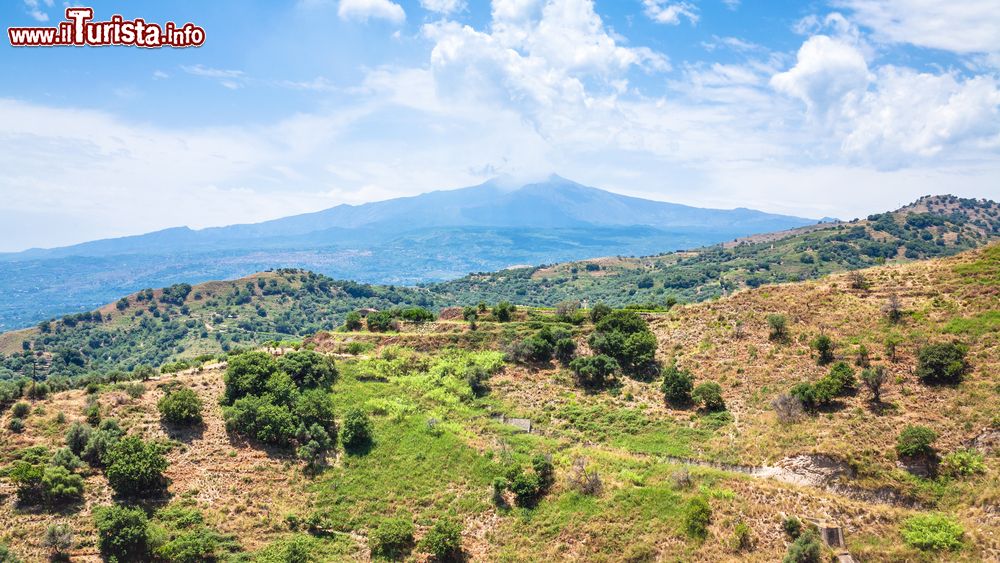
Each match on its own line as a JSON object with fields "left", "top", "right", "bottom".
{"left": 7, "top": 8, "right": 205, "bottom": 49}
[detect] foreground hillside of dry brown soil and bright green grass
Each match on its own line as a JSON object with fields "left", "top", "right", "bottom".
{"left": 0, "top": 245, "right": 1000, "bottom": 561}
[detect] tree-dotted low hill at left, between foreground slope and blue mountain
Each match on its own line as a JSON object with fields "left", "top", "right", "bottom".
{"left": 0, "top": 269, "right": 433, "bottom": 378}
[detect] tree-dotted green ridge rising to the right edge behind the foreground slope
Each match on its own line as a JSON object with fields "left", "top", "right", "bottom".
{"left": 432, "top": 196, "right": 1000, "bottom": 306}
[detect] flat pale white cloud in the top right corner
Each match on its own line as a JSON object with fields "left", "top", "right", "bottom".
{"left": 835, "top": 0, "right": 1000, "bottom": 53}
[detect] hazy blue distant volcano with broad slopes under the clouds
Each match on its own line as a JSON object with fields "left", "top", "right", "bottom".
{"left": 0, "top": 176, "right": 817, "bottom": 330}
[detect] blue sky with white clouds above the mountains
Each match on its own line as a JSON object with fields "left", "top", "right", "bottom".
{"left": 0, "top": 0, "right": 1000, "bottom": 251}
